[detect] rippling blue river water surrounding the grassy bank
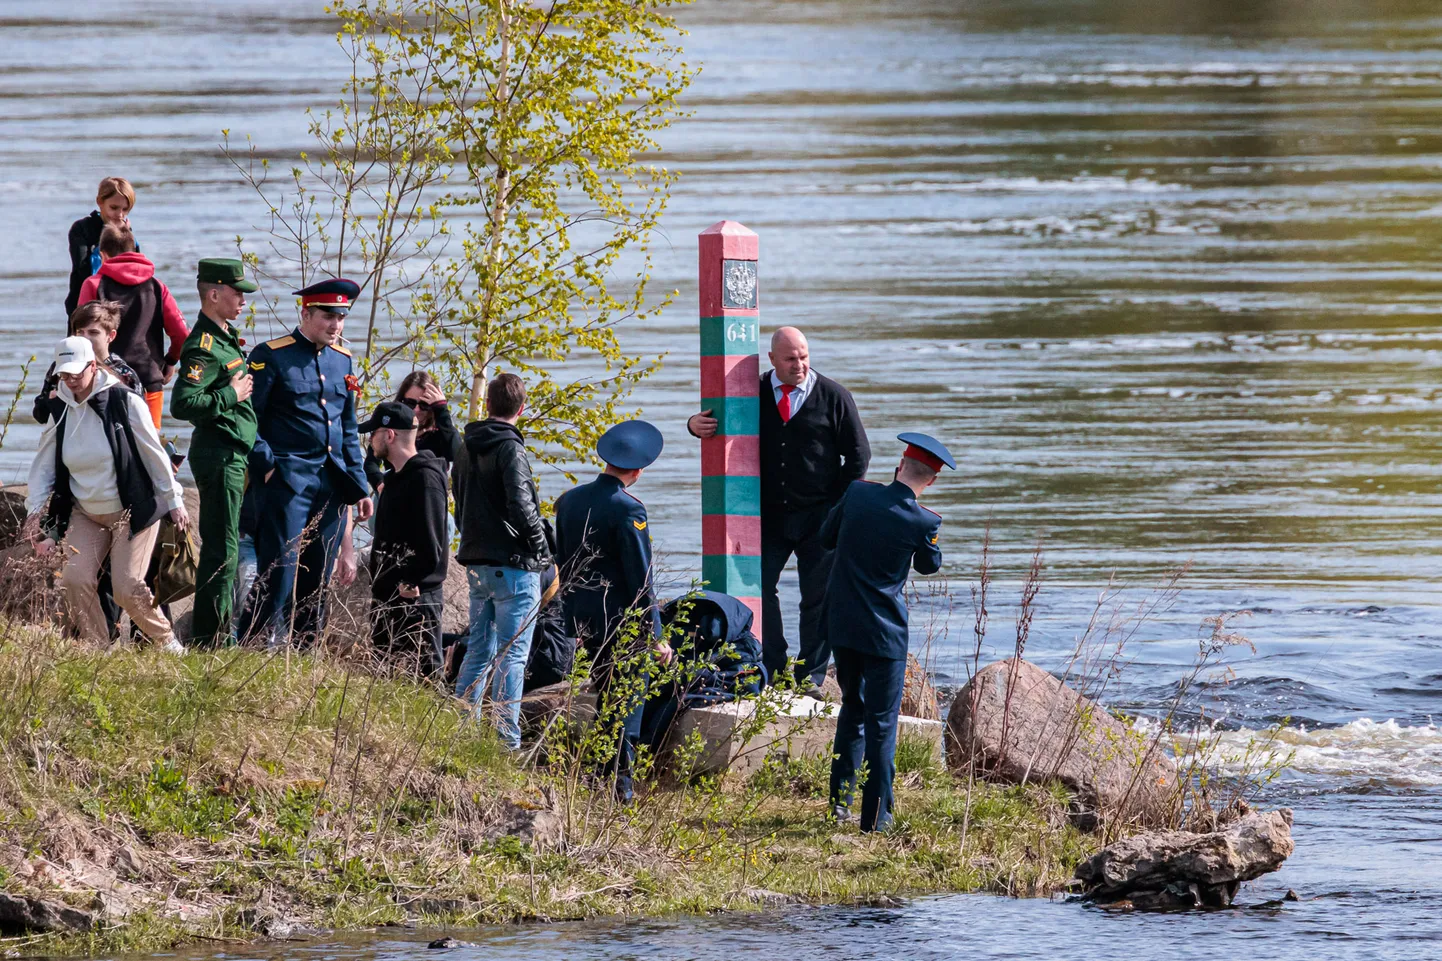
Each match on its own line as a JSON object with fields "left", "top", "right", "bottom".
{"left": 0, "top": 0, "right": 1442, "bottom": 960}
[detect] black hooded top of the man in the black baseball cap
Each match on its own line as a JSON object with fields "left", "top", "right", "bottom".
{"left": 371, "top": 450, "right": 450, "bottom": 600}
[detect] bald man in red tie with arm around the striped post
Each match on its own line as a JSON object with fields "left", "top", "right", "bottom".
{"left": 686, "top": 328, "right": 871, "bottom": 694}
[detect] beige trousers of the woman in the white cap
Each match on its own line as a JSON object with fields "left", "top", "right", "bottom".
{"left": 61, "top": 505, "right": 174, "bottom": 644}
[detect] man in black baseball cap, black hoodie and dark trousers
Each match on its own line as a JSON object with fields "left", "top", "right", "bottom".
{"left": 359, "top": 401, "right": 450, "bottom": 677}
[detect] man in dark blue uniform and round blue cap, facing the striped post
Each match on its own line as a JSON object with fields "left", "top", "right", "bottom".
{"left": 555, "top": 420, "right": 671, "bottom": 801}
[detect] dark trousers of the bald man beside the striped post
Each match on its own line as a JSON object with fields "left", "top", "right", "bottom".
{"left": 761, "top": 505, "right": 832, "bottom": 685}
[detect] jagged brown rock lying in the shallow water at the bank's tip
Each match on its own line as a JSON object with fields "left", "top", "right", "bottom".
{"left": 1076, "top": 808, "right": 1292, "bottom": 910}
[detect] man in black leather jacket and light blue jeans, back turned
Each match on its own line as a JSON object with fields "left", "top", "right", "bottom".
{"left": 456, "top": 374, "right": 551, "bottom": 750}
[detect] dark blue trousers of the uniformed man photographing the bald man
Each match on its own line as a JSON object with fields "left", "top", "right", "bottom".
{"left": 831, "top": 648, "right": 906, "bottom": 831}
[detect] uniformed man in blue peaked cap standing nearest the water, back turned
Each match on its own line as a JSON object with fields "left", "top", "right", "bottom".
{"left": 820, "top": 433, "right": 956, "bottom": 831}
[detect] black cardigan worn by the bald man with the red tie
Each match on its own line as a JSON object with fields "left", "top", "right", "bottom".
{"left": 760, "top": 371, "right": 871, "bottom": 517}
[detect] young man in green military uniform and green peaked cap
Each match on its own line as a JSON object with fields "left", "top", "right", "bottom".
{"left": 170, "top": 258, "right": 257, "bottom": 646}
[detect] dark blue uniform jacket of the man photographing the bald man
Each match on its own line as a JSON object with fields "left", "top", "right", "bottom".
{"left": 820, "top": 481, "right": 942, "bottom": 661}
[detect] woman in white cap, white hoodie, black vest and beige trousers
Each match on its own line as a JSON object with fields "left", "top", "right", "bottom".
{"left": 25, "top": 338, "right": 190, "bottom": 652}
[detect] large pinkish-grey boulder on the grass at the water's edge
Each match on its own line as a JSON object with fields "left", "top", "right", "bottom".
{"left": 946, "top": 658, "right": 1180, "bottom": 830}
